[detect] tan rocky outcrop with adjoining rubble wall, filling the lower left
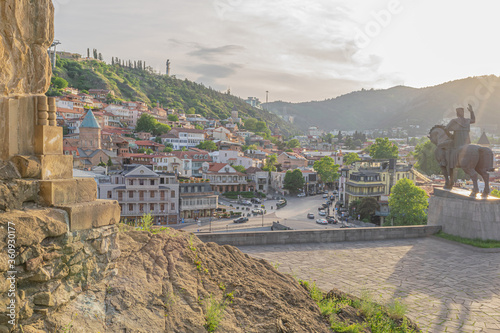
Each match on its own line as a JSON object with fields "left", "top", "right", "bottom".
{"left": 0, "top": 208, "right": 330, "bottom": 333}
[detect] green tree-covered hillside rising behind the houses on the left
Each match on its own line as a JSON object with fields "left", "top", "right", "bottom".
{"left": 53, "top": 58, "right": 298, "bottom": 136}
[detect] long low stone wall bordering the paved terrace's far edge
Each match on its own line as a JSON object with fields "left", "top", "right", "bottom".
{"left": 197, "top": 226, "right": 441, "bottom": 246}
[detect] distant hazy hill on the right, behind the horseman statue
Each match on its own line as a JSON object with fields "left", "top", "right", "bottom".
{"left": 265, "top": 75, "right": 500, "bottom": 133}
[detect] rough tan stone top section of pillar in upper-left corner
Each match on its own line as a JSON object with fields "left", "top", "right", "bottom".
{"left": 0, "top": 0, "right": 54, "bottom": 97}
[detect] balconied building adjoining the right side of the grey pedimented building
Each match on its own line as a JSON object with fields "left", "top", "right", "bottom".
{"left": 179, "top": 178, "right": 219, "bottom": 220}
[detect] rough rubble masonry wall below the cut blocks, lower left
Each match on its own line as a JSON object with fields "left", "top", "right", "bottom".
{"left": 0, "top": 208, "right": 120, "bottom": 333}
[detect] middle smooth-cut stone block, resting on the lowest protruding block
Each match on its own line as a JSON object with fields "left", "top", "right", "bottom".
{"left": 39, "top": 178, "right": 97, "bottom": 206}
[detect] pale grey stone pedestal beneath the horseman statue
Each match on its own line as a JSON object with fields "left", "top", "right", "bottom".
{"left": 427, "top": 188, "right": 500, "bottom": 240}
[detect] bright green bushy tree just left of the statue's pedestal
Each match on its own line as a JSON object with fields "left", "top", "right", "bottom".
{"left": 386, "top": 178, "right": 429, "bottom": 225}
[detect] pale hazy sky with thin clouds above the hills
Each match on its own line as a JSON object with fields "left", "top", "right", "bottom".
{"left": 53, "top": 0, "right": 500, "bottom": 102}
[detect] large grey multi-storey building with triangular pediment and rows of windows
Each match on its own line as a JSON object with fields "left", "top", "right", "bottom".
{"left": 99, "top": 165, "right": 179, "bottom": 224}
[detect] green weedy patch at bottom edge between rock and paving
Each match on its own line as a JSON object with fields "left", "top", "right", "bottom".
{"left": 299, "top": 280, "right": 420, "bottom": 333}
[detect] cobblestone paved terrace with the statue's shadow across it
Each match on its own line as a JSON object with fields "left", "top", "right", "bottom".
{"left": 240, "top": 237, "right": 500, "bottom": 333}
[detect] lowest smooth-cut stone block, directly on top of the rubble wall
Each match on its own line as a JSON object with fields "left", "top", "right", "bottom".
{"left": 59, "top": 199, "right": 120, "bottom": 231}
